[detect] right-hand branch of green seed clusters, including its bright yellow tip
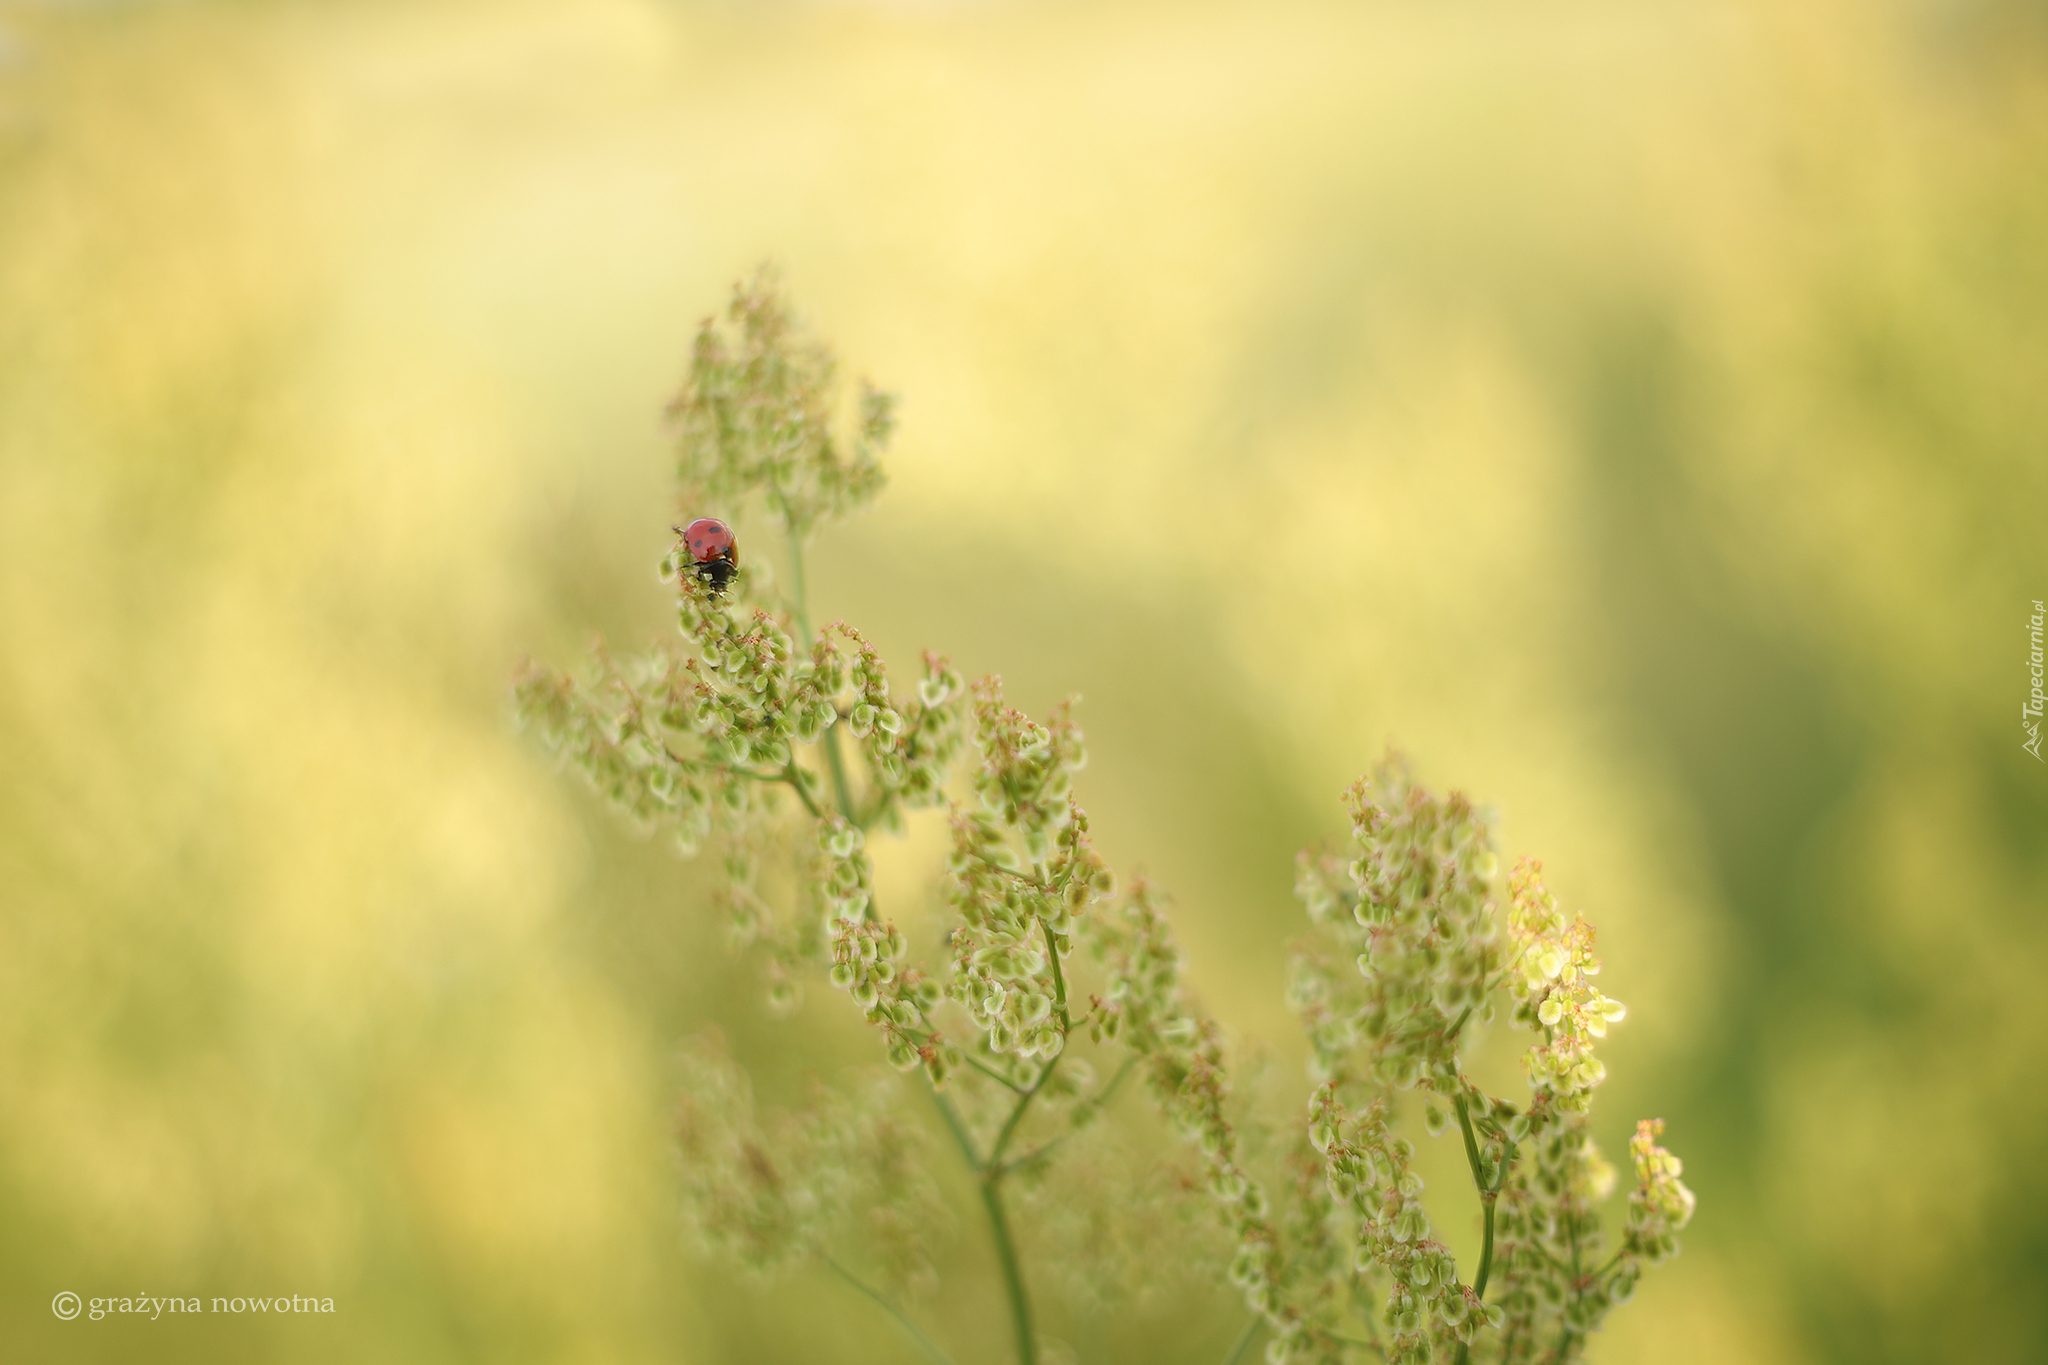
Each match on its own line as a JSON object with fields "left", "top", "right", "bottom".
{"left": 1276, "top": 759, "right": 1690, "bottom": 1365}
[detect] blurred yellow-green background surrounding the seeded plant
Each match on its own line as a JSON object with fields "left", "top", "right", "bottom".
{"left": 0, "top": 0, "right": 2048, "bottom": 1365}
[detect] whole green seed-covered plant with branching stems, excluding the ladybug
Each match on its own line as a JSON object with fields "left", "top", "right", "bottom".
{"left": 518, "top": 276, "right": 1694, "bottom": 1365}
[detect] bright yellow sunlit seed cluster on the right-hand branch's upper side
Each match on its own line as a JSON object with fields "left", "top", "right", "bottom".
{"left": 1507, "top": 857, "right": 1628, "bottom": 1109}
